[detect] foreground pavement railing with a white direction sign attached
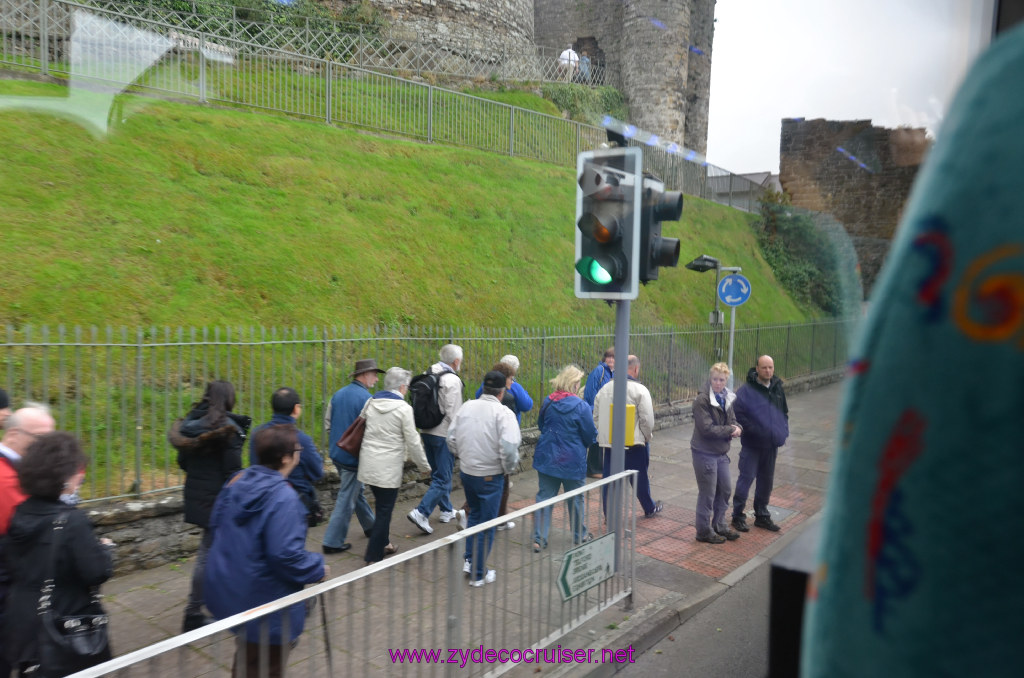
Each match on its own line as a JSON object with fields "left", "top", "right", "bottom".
{"left": 68, "top": 471, "right": 636, "bottom": 678}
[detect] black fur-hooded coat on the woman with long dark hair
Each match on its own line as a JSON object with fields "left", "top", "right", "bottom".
{"left": 167, "top": 405, "right": 252, "bottom": 527}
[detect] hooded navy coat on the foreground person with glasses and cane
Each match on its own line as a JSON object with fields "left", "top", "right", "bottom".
{"left": 204, "top": 466, "right": 324, "bottom": 645}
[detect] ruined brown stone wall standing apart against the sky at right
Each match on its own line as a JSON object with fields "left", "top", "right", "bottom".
{"left": 779, "top": 119, "right": 931, "bottom": 295}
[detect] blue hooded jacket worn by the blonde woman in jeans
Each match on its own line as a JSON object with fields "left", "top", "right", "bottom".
{"left": 534, "top": 391, "right": 597, "bottom": 479}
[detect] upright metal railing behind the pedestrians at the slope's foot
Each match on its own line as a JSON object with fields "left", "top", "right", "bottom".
{"left": 0, "top": 321, "right": 853, "bottom": 499}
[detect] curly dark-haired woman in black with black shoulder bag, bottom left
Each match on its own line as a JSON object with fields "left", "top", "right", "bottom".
{"left": 2, "top": 431, "right": 114, "bottom": 678}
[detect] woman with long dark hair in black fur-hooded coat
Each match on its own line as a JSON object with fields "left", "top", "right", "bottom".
{"left": 167, "top": 381, "right": 252, "bottom": 633}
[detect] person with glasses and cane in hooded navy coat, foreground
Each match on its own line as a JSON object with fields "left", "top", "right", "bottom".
{"left": 206, "top": 424, "right": 330, "bottom": 677}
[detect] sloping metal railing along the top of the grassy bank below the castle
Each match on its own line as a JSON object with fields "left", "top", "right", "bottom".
{"left": 0, "top": 0, "right": 764, "bottom": 211}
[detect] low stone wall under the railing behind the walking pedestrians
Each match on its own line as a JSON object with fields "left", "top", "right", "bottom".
{"left": 88, "top": 369, "right": 844, "bottom": 575}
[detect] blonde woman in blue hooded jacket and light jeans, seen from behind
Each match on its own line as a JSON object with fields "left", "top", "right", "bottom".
{"left": 534, "top": 365, "right": 597, "bottom": 553}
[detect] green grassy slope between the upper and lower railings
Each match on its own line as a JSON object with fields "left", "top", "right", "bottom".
{"left": 0, "top": 81, "right": 806, "bottom": 327}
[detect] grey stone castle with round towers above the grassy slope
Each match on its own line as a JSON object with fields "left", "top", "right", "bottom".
{"left": 328, "top": 0, "right": 716, "bottom": 154}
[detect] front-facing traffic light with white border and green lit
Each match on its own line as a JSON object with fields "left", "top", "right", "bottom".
{"left": 574, "top": 149, "right": 641, "bottom": 299}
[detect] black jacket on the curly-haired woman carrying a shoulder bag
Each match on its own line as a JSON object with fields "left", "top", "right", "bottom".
{"left": 3, "top": 497, "right": 114, "bottom": 666}
